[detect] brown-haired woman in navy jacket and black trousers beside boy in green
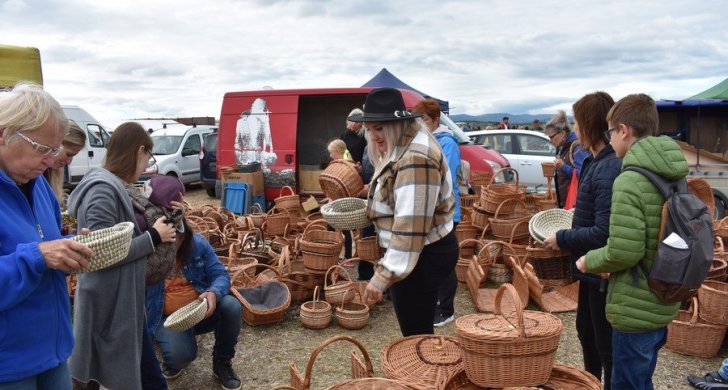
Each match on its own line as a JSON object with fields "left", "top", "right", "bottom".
{"left": 545, "top": 92, "right": 622, "bottom": 389}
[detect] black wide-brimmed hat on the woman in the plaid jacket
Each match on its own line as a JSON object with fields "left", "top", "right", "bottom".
{"left": 346, "top": 88, "right": 421, "bottom": 122}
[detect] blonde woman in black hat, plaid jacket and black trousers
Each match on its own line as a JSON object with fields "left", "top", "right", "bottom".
{"left": 348, "top": 88, "right": 458, "bottom": 336}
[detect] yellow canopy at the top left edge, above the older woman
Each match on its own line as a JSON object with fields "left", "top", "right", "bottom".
{"left": 0, "top": 45, "right": 43, "bottom": 89}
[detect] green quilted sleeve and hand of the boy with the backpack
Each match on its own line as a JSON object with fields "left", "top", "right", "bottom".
{"left": 585, "top": 174, "right": 647, "bottom": 273}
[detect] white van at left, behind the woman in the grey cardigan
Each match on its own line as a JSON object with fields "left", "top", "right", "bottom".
{"left": 62, "top": 106, "right": 110, "bottom": 185}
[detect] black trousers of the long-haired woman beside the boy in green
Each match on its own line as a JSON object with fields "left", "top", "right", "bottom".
{"left": 576, "top": 280, "right": 612, "bottom": 389}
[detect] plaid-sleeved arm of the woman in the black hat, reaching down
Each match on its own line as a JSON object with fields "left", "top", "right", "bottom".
{"left": 371, "top": 153, "right": 442, "bottom": 291}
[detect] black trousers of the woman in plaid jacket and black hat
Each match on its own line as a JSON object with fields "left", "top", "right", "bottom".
{"left": 389, "top": 232, "right": 458, "bottom": 337}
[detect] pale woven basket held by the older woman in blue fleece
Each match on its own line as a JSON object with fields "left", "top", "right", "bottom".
{"left": 68, "top": 222, "right": 134, "bottom": 275}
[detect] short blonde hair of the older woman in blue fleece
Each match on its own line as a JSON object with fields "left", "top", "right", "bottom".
{"left": 0, "top": 82, "right": 68, "bottom": 140}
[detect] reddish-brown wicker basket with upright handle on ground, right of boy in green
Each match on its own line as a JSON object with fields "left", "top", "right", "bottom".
{"left": 665, "top": 297, "right": 726, "bottom": 359}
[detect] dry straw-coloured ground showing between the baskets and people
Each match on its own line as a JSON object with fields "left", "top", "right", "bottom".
{"left": 169, "top": 187, "right": 728, "bottom": 390}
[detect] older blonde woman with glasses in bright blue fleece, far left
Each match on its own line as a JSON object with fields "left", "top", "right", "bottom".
{"left": 0, "top": 84, "right": 93, "bottom": 390}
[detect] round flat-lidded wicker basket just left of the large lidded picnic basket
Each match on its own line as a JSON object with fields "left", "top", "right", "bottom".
{"left": 379, "top": 335, "right": 463, "bottom": 389}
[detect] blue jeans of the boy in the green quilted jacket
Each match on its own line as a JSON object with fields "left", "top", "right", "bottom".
{"left": 612, "top": 327, "right": 667, "bottom": 390}
